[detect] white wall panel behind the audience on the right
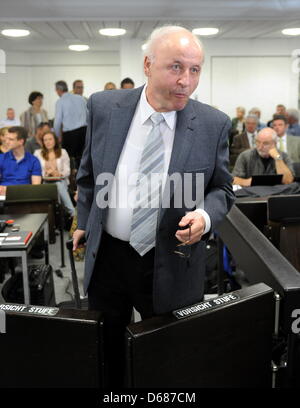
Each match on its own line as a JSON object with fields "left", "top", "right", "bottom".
{"left": 211, "top": 56, "right": 297, "bottom": 122}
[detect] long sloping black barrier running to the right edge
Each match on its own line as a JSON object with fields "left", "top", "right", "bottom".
{"left": 218, "top": 206, "right": 300, "bottom": 334}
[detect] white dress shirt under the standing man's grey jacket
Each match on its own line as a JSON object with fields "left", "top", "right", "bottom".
{"left": 104, "top": 86, "right": 211, "bottom": 241}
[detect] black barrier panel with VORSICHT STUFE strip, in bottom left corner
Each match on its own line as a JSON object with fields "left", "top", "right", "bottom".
{"left": 0, "top": 304, "right": 103, "bottom": 388}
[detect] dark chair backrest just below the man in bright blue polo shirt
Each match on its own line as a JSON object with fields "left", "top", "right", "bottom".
{"left": 6, "top": 183, "right": 58, "bottom": 202}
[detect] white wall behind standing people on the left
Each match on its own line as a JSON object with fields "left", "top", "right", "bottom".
{"left": 0, "top": 52, "right": 120, "bottom": 118}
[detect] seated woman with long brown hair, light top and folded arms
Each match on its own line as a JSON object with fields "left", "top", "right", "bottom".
{"left": 34, "top": 132, "right": 75, "bottom": 217}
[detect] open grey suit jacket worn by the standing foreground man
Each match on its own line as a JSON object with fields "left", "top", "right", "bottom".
{"left": 77, "top": 87, "right": 234, "bottom": 313}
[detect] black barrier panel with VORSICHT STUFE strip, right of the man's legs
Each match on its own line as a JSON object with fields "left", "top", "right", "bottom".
{"left": 127, "top": 284, "right": 274, "bottom": 388}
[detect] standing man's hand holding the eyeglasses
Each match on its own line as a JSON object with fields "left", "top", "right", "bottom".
{"left": 175, "top": 211, "right": 205, "bottom": 245}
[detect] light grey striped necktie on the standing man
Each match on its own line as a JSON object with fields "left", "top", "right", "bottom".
{"left": 129, "top": 112, "right": 164, "bottom": 256}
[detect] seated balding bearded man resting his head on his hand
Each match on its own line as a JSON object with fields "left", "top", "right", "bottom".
{"left": 232, "top": 127, "right": 294, "bottom": 187}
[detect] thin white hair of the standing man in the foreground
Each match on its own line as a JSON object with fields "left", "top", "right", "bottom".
{"left": 143, "top": 25, "right": 204, "bottom": 65}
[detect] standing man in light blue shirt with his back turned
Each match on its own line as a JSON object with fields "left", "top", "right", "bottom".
{"left": 53, "top": 81, "right": 87, "bottom": 168}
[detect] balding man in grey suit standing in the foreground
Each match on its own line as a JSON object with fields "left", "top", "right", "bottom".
{"left": 73, "top": 27, "right": 234, "bottom": 384}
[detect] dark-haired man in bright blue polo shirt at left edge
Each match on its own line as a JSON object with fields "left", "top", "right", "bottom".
{"left": 0, "top": 126, "right": 42, "bottom": 194}
